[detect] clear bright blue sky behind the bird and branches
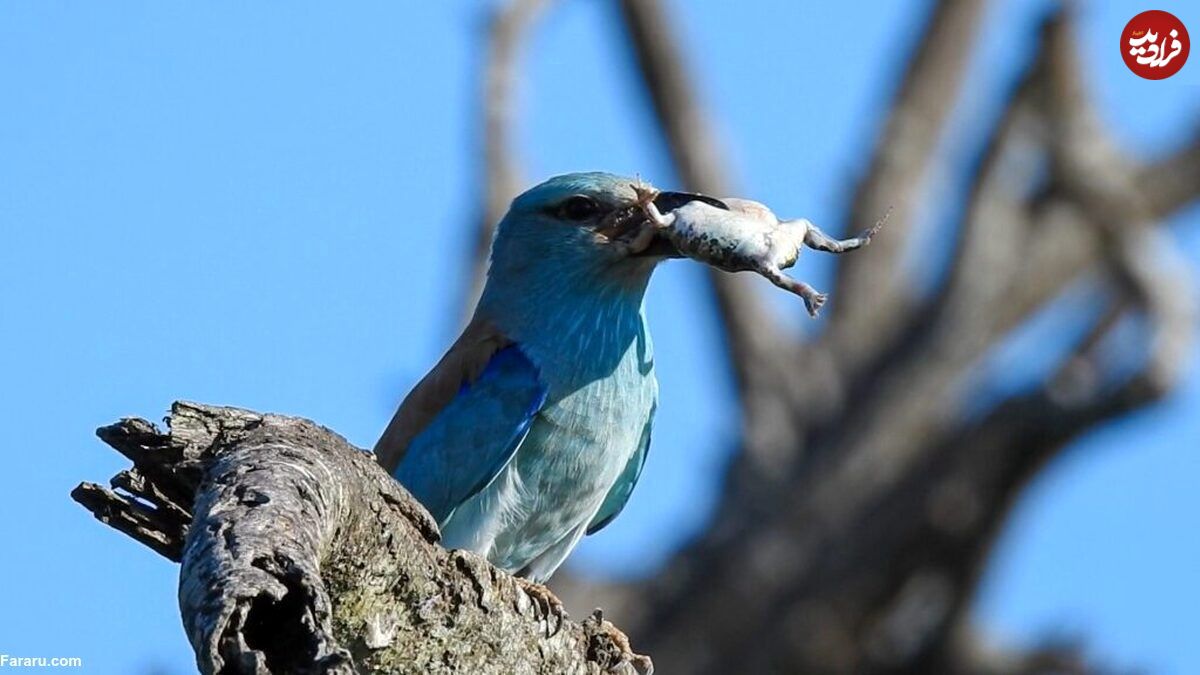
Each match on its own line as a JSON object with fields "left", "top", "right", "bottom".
{"left": 0, "top": 0, "right": 1200, "bottom": 674}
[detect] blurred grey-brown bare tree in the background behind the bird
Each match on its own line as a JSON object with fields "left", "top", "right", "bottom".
{"left": 465, "top": 0, "right": 1200, "bottom": 674}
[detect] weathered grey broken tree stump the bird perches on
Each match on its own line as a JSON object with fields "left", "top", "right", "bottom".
{"left": 72, "top": 402, "right": 638, "bottom": 674}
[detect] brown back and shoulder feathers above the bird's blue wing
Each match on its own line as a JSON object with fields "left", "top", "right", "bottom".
{"left": 374, "top": 319, "right": 512, "bottom": 473}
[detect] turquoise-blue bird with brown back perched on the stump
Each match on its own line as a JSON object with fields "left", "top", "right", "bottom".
{"left": 374, "top": 173, "right": 725, "bottom": 584}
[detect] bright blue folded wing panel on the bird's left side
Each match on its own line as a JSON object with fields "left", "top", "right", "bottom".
{"left": 394, "top": 345, "right": 546, "bottom": 522}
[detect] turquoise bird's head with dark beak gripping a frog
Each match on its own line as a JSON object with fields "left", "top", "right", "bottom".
{"left": 492, "top": 172, "right": 726, "bottom": 283}
